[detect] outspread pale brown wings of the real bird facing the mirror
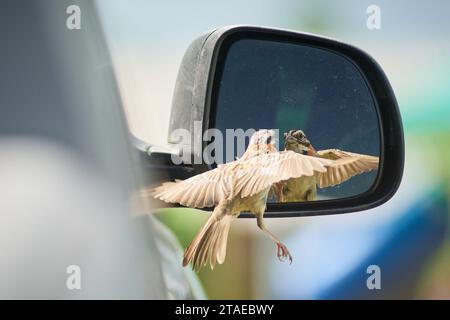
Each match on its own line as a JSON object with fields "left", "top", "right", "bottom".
{"left": 152, "top": 151, "right": 333, "bottom": 208}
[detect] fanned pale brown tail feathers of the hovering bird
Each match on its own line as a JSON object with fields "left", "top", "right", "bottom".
{"left": 183, "top": 208, "right": 233, "bottom": 271}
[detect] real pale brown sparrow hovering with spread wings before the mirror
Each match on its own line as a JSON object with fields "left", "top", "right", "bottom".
{"left": 152, "top": 129, "right": 332, "bottom": 271}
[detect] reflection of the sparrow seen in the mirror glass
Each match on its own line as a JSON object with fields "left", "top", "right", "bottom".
{"left": 273, "top": 129, "right": 379, "bottom": 202}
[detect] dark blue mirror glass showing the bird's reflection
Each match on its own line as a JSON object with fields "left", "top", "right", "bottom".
{"left": 210, "top": 38, "right": 380, "bottom": 202}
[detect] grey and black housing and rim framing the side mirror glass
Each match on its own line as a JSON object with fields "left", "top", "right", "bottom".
{"left": 165, "top": 25, "right": 404, "bottom": 217}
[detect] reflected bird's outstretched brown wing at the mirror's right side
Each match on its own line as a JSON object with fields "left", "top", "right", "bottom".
{"left": 316, "top": 149, "right": 379, "bottom": 188}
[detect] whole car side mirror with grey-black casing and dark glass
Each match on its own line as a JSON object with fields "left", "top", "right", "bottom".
{"left": 152, "top": 26, "right": 404, "bottom": 217}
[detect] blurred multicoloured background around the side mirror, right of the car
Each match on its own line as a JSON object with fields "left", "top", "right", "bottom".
{"left": 97, "top": 0, "right": 450, "bottom": 299}
